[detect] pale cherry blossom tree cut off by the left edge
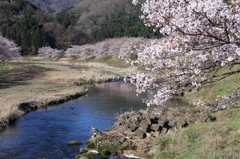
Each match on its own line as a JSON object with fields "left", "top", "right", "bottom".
{"left": 0, "top": 35, "right": 22, "bottom": 64}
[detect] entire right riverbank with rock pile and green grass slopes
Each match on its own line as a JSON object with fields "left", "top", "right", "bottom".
{"left": 73, "top": 62, "right": 240, "bottom": 159}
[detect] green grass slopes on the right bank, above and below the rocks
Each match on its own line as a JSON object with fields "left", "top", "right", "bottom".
{"left": 154, "top": 65, "right": 240, "bottom": 159}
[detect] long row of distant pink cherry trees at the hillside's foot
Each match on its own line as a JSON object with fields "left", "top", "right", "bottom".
{"left": 64, "top": 37, "right": 151, "bottom": 59}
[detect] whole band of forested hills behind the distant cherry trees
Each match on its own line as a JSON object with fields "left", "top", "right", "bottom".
{"left": 0, "top": 0, "right": 160, "bottom": 55}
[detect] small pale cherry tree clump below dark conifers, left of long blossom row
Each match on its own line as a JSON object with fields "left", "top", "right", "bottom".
{"left": 38, "top": 46, "right": 64, "bottom": 58}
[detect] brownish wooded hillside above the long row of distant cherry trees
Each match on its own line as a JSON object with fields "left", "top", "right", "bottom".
{"left": 52, "top": 0, "right": 161, "bottom": 47}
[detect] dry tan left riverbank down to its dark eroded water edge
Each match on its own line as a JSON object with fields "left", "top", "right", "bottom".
{"left": 0, "top": 61, "right": 130, "bottom": 129}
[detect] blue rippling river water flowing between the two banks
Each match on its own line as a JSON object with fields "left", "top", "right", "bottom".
{"left": 0, "top": 82, "right": 186, "bottom": 159}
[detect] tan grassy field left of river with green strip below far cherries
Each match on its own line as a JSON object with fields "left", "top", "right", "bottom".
{"left": 0, "top": 57, "right": 144, "bottom": 129}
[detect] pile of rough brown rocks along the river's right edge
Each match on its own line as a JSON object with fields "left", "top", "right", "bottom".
{"left": 76, "top": 107, "right": 214, "bottom": 159}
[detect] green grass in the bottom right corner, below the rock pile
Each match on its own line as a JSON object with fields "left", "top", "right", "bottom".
{"left": 154, "top": 109, "right": 240, "bottom": 159}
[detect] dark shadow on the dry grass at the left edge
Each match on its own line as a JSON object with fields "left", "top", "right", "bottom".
{"left": 0, "top": 63, "right": 54, "bottom": 89}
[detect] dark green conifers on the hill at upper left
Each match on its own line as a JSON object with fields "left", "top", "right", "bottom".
{"left": 0, "top": 0, "right": 48, "bottom": 55}
